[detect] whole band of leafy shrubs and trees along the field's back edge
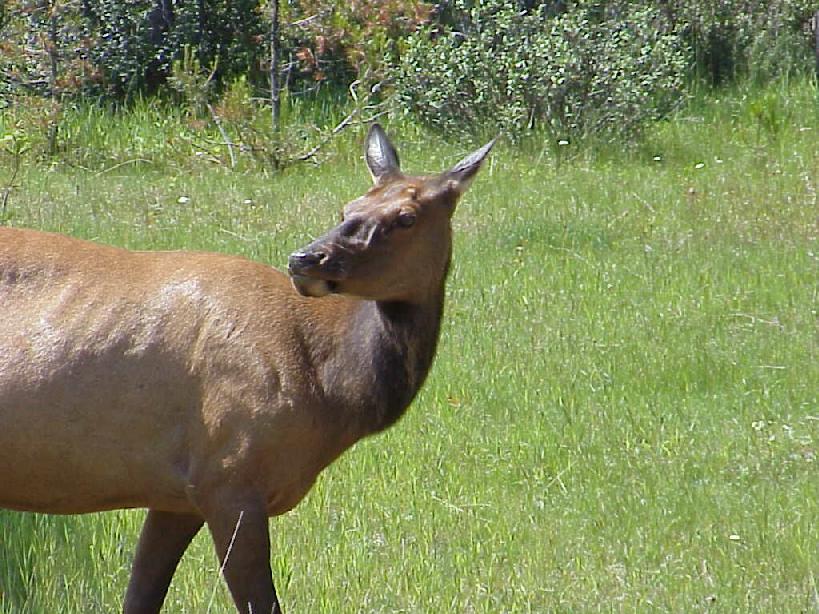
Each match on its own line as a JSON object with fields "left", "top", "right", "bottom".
{"left": 0, "top": 0, "right": 815, "bottom": 143}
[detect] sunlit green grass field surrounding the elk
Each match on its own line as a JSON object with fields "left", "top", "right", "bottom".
{"left": 0, "top": 83, "right": 819, "bottom": 614}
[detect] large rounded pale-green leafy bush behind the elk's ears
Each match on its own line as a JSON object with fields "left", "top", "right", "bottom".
{"left": 394, "top": 0, "right": 689, "bottom": 138}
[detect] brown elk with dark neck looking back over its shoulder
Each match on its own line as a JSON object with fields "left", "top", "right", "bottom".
{"left": 0, "top": 124, "right": 494, "bottom": 614}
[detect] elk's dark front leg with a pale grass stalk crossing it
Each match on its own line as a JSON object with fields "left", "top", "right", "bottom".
{"left": 206, "top": 501, "right": 281, "bottom": 614}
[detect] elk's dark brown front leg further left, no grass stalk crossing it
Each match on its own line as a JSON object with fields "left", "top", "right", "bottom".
{"left": 123, "top": 510, "right": 204, "bottom": 614}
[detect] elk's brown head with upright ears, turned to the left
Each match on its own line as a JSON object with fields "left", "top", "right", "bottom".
{"left": 289, "top": 124, "right": 495, "bottom": 302}
